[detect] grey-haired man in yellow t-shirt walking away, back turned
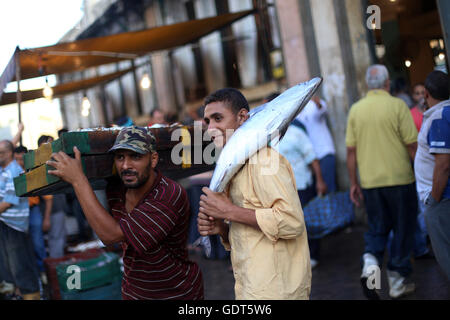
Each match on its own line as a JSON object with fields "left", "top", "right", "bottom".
{"left": 346, "top": 65, "right": 418, "bottom": 299}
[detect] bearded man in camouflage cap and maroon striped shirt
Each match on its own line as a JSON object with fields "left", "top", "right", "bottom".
{"left": 47, "top": 126, "right": 203, "bottom": 300}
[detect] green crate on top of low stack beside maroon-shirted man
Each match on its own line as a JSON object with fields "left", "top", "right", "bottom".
{"left": 56, "top": 252, "right": 122, "bottom": 292}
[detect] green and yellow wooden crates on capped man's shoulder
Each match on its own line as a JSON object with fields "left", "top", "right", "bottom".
{"left": 14, "top": 126, "right": 214, "bottom": 197}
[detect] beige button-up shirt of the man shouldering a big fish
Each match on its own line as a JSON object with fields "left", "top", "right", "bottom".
{"left": 224, "top": 148, "right": 311, "bottom": 300}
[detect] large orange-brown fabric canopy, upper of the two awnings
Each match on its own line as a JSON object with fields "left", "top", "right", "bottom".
{"left": 0, "top": 10, "right": 254, "bottom": 83}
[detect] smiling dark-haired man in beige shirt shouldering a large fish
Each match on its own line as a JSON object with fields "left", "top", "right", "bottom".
{"left": 197, "top": 88, "right": 311, "bottom": 300}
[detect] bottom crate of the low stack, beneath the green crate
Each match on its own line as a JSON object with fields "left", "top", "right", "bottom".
{"left": 61, "top": 278, "right": 122, "bottom": 300}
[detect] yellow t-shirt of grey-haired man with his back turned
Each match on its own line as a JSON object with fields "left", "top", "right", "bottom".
{"left": 346, "top": 90, "right": 417, "bottom": 189}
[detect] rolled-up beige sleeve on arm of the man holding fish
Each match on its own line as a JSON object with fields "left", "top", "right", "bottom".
{"left": 250, "top": 149, "right": 305, "bottom": 242}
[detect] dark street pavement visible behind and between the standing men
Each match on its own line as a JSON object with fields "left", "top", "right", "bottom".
{"left": 190, "top": 226, "right": 450, "bottom": 300}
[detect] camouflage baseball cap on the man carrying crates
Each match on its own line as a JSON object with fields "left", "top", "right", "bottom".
{"left": 108, "top": 126, "right": 156, "bottom": 154}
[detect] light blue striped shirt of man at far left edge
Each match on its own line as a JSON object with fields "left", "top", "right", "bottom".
{"left": 0, "top": 160, "right": 30, "bottom": 232}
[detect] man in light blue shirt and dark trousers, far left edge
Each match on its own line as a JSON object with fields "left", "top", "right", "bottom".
{"left": 0, "top": 140, "right": 40, "bottom": 300}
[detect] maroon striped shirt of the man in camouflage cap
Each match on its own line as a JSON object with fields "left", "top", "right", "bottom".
{"left": 107, "top": 171, "right": 203, "bottom": 300}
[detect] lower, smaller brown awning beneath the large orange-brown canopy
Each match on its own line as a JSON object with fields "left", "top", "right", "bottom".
{"left": 0, "top": 68, "right": 133, "bottom": 106}
